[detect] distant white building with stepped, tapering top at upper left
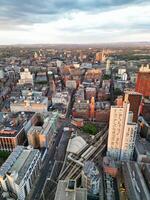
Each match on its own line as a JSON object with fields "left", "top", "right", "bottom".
{"left": 18, "top": 68, "right": 33, "bottom": 85}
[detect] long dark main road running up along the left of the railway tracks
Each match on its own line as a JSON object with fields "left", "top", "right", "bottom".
{"left": 27, "top": 90, "right": 76, "bottom": 200}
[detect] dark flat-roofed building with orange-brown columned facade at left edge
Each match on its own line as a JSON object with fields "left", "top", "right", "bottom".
{"left": 0, "top": 112, "right": 33, "bottom": 151}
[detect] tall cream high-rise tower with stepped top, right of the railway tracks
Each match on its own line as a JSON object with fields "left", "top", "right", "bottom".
{"left": 107, "top": 99, "right": 137, "bottom": 160}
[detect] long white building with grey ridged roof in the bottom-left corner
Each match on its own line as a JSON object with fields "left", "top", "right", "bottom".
{"left": 0, "top": 146, "right": 41, "bottom": 200}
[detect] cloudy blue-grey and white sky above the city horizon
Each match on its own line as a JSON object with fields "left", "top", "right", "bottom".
{"left": 0, "top": 0, "right": 150, "bottom": 45}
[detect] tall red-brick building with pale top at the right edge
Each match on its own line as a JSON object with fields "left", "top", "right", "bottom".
{"left": 136, "top": 65, "right": 150, "bottom": 97}
